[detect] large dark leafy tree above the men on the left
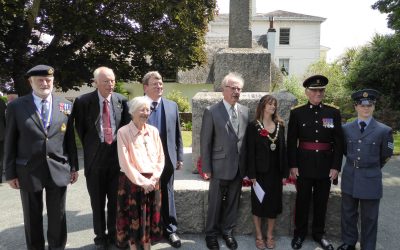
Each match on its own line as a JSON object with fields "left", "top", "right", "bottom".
{"left": 0, "top": 0, "right": 215, "bottom": 94}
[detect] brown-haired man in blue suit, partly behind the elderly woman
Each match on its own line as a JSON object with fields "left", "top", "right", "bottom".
{"left": 142, "top": 71, "right": 183, "bottom": 248}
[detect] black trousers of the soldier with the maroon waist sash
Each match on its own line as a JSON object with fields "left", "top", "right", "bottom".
{"left": 294, "top": 176, "right": 331, "bottom": 240}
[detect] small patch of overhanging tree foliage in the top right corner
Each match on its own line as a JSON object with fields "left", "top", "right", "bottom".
{"left": 372, "top": 0, "right": 400, "bottom": 32}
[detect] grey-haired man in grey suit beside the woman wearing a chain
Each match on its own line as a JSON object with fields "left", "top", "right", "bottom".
{"left": 200, "top": 73, "right": 249, "bottom": 249}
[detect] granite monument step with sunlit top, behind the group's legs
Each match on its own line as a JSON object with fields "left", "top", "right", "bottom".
{"left": 174, "top": 148, "right": 341, "bottom": 239}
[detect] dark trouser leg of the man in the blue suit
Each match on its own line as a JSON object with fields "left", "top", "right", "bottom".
{"left": 160, "top": 162, "right": 178, "bottom": 235}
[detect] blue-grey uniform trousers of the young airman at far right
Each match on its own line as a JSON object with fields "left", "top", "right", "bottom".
{"left": 342, "top": 192, "right": 380, "bottom": 250}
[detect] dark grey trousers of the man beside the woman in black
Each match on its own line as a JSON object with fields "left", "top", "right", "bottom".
{"left": 205, "top": 174, "right": 242, "bottom": 236}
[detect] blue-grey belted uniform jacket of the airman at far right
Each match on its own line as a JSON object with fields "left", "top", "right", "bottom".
{"left": 341, "top": 119, "right": 393, "bottom": 199}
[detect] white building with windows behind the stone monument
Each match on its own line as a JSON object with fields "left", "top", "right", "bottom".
{"left": 206, "top": 10, "right": 329, "bottom": 77}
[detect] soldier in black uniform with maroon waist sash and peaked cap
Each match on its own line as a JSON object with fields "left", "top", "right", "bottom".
{"left": 287, "top": 75, "right": 343, "bottom": 250}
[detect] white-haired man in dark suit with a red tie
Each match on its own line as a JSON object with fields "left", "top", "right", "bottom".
{"left": 73, "top": 67, "right": 130, "bottom": 249}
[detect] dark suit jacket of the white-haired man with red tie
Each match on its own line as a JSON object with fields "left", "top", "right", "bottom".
{"left": 72, "top": 89, "right": 131, "bottom": 175}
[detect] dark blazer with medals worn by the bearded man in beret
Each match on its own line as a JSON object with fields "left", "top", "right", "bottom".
{"left": 4, "top": 94, "right": 78, "bottom": 191}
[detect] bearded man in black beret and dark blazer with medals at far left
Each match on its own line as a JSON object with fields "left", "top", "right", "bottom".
{"left": 4, "top": 65, "right": 78, "bottom": 249}
